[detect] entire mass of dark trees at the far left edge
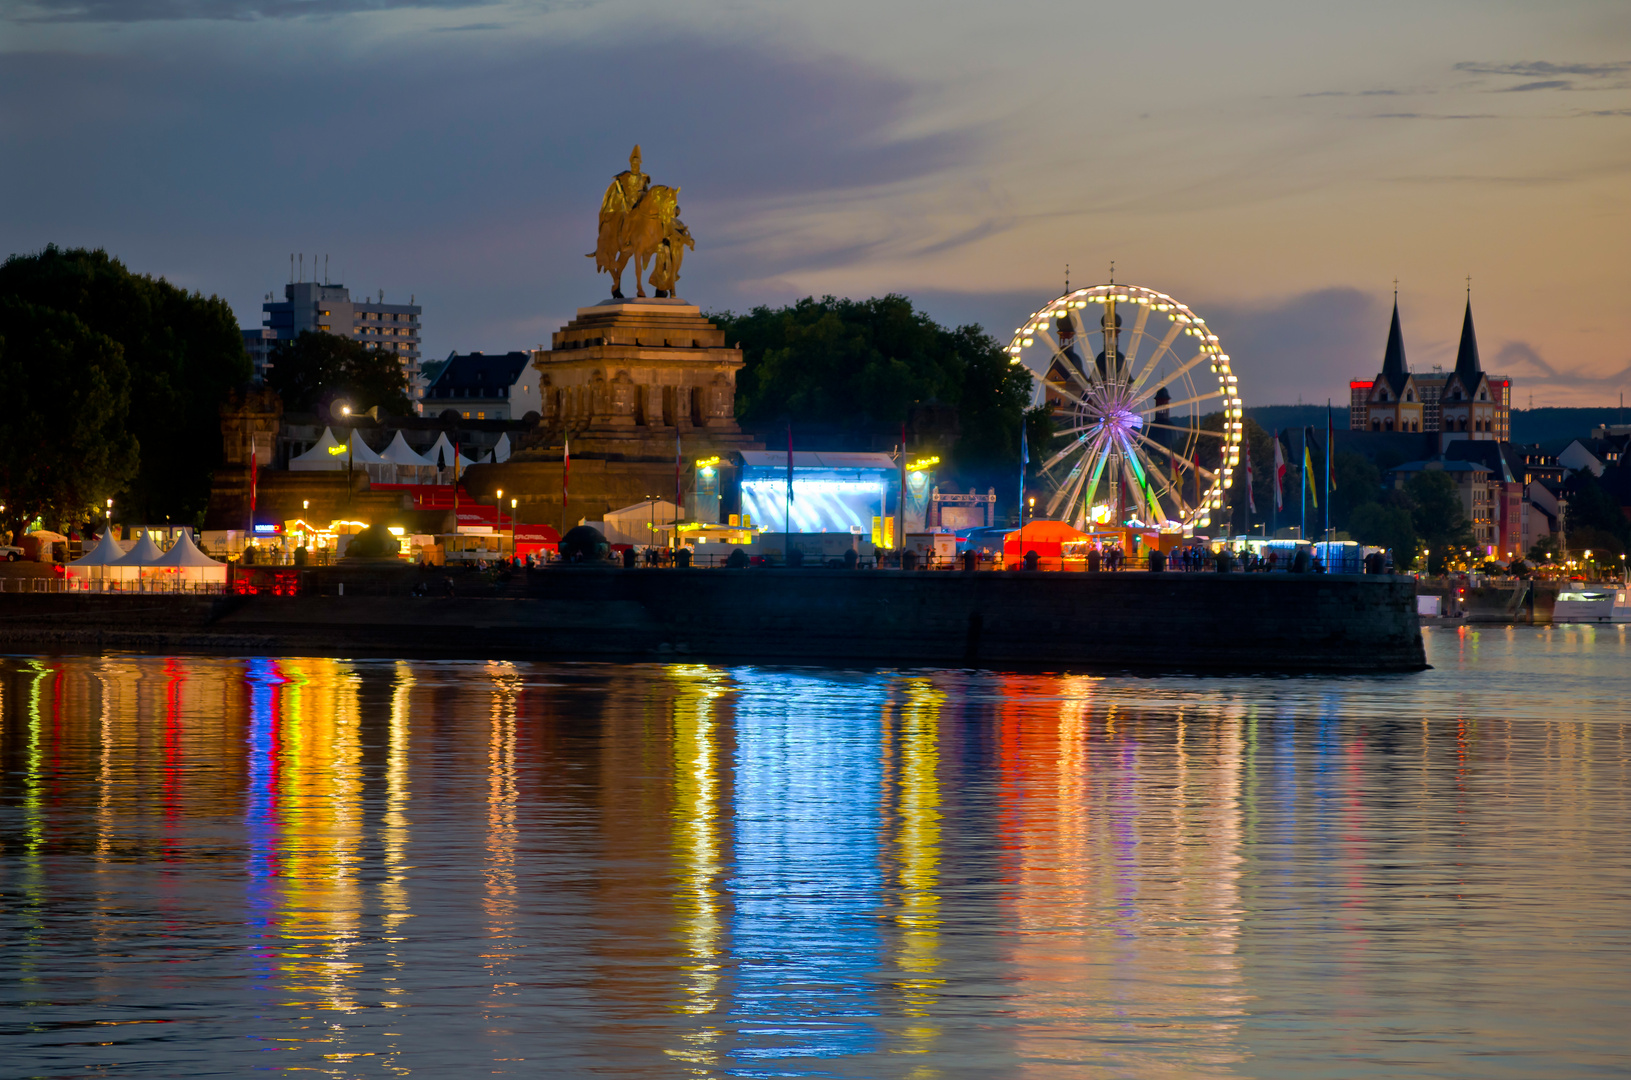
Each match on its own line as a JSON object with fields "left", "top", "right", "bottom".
{"left": 0, "top": 246, "right": 250, "bottom": 532}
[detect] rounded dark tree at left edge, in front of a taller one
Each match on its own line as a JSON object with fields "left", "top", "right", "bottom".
{"left": 0, "top": 297, "right": 137, "bottom": 535}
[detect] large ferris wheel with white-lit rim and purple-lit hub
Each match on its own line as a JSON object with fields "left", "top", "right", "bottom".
{"left": 1008, "top": 284, "right": 1244, "bottom": 532}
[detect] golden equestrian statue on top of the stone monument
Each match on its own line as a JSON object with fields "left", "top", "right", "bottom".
{"left": 589, "top": 145, "right": 696, "bottom": 300}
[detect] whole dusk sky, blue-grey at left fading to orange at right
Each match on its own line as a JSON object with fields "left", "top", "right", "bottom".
{"left": 0, "top": 0, "right": 1631, "bottom": 406}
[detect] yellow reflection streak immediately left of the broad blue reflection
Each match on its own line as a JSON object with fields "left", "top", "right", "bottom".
{"left": 667, "top": 664, "right": 727, "bottom": 1075}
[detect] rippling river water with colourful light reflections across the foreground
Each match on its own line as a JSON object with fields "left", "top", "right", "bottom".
{"left": 0, "top": 628, "right": 1631, "bottom": 1078}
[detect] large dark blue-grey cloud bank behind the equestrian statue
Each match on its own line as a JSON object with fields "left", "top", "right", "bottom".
{"left": 0, "top": 34, "right": 972, "bottom": 356}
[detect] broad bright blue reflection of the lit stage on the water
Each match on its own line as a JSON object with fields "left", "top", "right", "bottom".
{"left": 731, "top": 674, "right": 887, "bottom": 1072}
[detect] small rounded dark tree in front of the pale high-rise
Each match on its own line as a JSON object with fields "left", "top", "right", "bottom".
{"left": 266, "top": 330, "right": 413, "bottom": 416}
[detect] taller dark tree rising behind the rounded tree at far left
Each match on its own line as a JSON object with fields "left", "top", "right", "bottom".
{"left": 0, "top": 245, "right": 251, "bottom": 520}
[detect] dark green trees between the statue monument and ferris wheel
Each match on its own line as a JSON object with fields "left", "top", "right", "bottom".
{"left": 709, "top": 295, "right": 1045, "bottom": 493}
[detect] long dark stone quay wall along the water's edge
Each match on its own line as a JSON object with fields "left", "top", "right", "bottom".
{"left": 0, "top": 566, "right": 1427, "bottom": 672}
